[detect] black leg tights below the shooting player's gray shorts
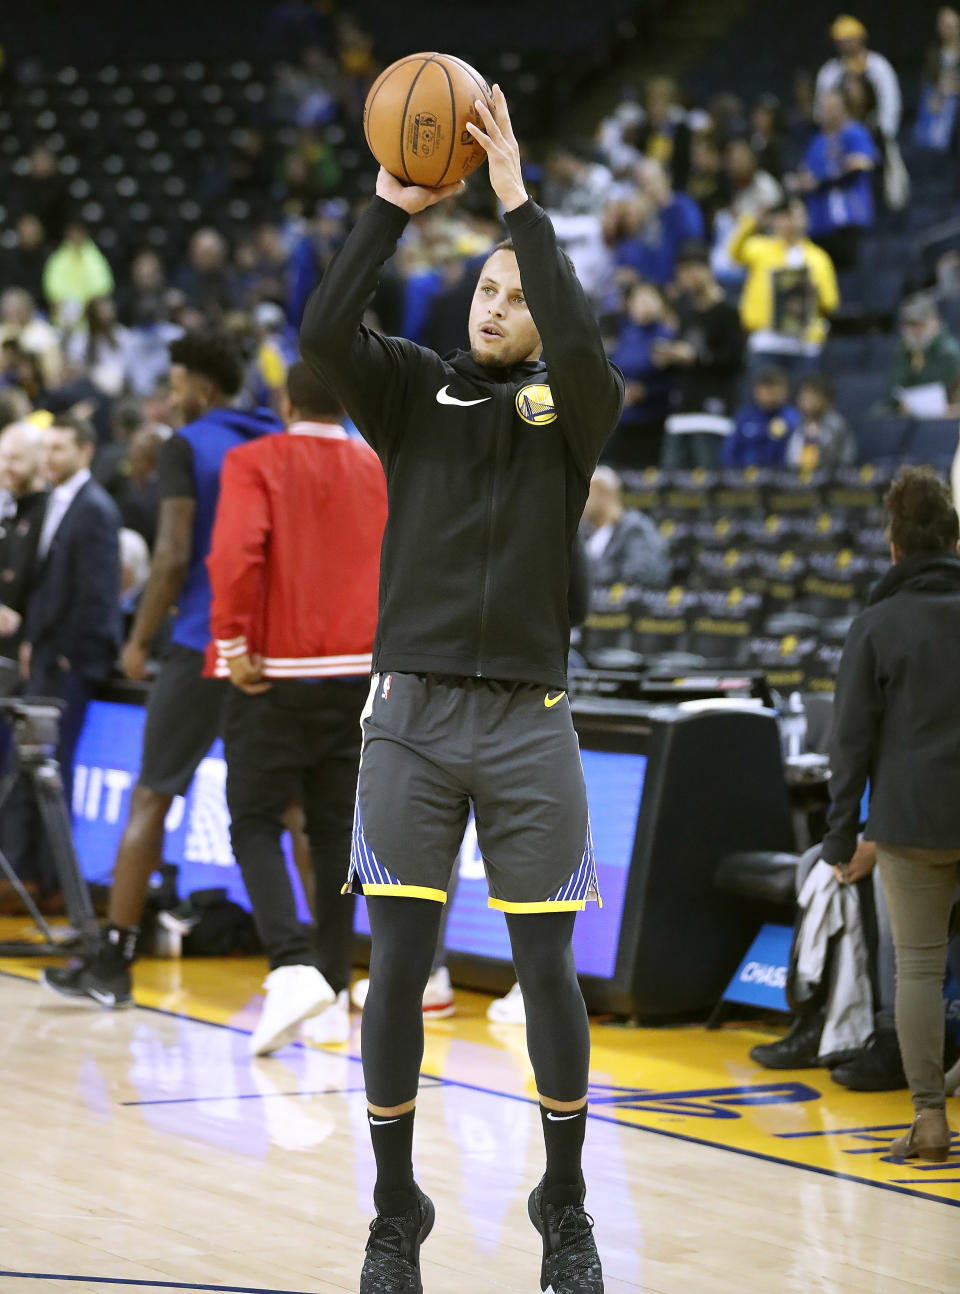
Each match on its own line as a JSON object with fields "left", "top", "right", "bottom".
{"left": 361, "top": 897, "right": 590, "bottom": 1109}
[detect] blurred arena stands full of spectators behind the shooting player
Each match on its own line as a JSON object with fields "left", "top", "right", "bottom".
{"left": 0, "top": 6, "right": 960, "bottom": 703}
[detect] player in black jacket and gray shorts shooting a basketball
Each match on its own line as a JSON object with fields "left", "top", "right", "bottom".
{"left": 307, "top": 88, "right": 624, "bottom": 1294}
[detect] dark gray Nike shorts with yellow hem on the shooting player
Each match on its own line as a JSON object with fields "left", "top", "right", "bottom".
{"left": 344, "top": 673, "right": 600, "bottom": 912}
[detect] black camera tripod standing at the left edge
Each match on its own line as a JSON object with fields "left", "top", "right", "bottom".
{"left": 0, "top": 696, "right": 97, "bottom": 956}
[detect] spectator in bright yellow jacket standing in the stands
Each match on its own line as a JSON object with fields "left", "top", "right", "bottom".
{"left": 728, "top": 198, "right": 840, "bottom": 377}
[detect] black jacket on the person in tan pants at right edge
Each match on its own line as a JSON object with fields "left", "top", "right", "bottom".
{"left": 823, "top": 553, "right": 960, "bottom": 864}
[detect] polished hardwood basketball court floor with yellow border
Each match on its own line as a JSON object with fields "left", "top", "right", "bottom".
{"left": 0, "top": 921, "right": 960, "bottom": 1294}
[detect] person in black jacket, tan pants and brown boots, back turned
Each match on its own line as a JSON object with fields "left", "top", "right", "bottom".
{"left": 823, "top": 467, "right": 960, "bottom": 1162}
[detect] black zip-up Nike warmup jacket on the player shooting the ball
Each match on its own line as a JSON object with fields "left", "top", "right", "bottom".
{"left": 300, "top": 198, "right": 624, "bottom": 688}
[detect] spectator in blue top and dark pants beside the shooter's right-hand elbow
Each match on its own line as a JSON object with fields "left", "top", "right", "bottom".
{"left": 603, "top": 283, "right": 674, "bottom": 470}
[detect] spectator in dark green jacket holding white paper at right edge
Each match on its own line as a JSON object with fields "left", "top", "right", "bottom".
{"left": 888, "top": 292, "right": 960, "bottom": 418}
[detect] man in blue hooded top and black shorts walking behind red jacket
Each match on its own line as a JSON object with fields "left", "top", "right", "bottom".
{"left": 43, "top": 333, "right": 282, "bottom": 1007}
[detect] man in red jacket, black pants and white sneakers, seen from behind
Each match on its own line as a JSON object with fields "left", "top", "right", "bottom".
{"left": 207, "top": 362, "right": 387, "bottom": 1056}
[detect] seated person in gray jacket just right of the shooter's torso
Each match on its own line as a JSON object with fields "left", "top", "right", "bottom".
{"left": 580, "top": 467, "right": 671, "bottom": 589}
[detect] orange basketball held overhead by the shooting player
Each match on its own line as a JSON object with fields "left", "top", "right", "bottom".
{"left": 364, "top": 53, "right": 493, "bottom": 189}
